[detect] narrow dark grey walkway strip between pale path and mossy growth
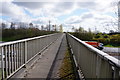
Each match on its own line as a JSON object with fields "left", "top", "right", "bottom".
{"left": 48, "top": 33, "right": 67, "bottom": 79}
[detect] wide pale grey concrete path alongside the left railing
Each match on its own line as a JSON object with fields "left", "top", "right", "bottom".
{"left": 25, "top": 34, "right": 65, "bottom": 78}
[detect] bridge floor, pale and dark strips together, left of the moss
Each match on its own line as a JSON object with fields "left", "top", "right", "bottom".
{"left": 11, "top": 35, "right": 67, "bottom": 78}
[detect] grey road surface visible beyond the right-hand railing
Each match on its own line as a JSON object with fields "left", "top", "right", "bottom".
{"left": 102, "top": 47, "right": 120, "bottom": 60}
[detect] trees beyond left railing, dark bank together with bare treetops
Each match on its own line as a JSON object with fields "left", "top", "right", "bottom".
{"left": 0, "top": 22, "right": 59, "bottom": 41}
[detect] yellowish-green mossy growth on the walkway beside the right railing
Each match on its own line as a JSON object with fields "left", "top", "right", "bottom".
{"left": 59, "top": 50, "right": 75, "bottom": 80}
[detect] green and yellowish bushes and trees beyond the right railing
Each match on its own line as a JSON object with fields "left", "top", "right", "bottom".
{"left": 71, "top": 27, "right": 120, "bottom": 46}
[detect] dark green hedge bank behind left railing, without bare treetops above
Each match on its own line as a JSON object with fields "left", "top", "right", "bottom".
{"left": 2, "top": 28, "right": 56, "bottom": 42}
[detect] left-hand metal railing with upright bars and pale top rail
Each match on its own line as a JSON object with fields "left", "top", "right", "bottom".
{"left": 0, "top": 33, "right": 62, "bottom": 79}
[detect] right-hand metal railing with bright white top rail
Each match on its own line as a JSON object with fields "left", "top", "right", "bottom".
{"left": 67, "top": 34, "right": 120, "bottom": 80}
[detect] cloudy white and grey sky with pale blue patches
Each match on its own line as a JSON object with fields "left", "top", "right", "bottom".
{"left": 0, "top": 0, "right": 118, "bottom": 32}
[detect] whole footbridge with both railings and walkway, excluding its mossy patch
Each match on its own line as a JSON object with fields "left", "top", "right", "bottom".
{"left": 0, "top": 33, "right": 120, "bottom": 80}
